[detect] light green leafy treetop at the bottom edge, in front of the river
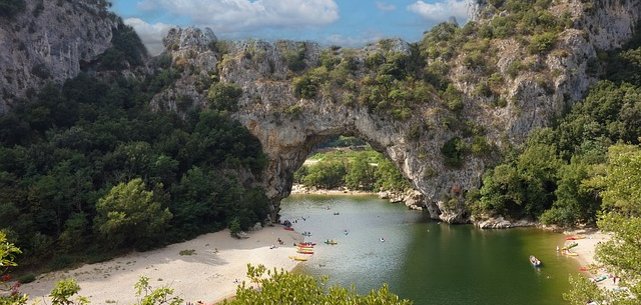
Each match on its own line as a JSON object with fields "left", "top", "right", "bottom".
{"left": 223, "top": 265, "right": 412, "bottom": 305}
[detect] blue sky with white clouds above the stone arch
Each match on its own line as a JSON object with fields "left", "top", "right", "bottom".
{"left": 112, "top": 0, "right": 470, "bottom": 54}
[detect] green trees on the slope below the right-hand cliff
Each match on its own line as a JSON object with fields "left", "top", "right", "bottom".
{"left": 469, "top": 32, "right": 641, "bottom": 226}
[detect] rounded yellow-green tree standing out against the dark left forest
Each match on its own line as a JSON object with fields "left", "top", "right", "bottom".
{"left": 94, "top": 178, "right": 173, "bottom": 247}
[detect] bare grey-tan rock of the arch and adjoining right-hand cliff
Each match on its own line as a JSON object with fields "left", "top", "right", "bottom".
{"left": 148, "top": 0, "right": 641, "bottom": 223}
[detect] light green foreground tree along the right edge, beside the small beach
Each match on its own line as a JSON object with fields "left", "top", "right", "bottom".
{"left": 564, "top": 145, "right": 641, "bottom": 305}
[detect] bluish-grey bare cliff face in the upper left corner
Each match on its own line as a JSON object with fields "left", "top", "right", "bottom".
{"left": 0, "top": 0, "right": 119, "bottom": 113}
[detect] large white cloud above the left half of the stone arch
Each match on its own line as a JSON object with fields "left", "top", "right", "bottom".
{"left": 138, "top": 0, "right": 339, "bottom": 33}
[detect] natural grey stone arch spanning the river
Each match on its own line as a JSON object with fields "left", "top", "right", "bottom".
{"left": 152, "top": 28, "right": 490, "bottom": 222}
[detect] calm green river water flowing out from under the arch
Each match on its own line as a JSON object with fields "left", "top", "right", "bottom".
{"left": 281, "top": 195, "right": 578, "bottom": 305}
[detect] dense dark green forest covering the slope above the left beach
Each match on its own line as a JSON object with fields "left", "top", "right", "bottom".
{"left": 0, "top": 25, "right": 268, "bottom": 269}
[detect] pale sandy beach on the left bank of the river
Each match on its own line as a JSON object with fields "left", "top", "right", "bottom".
{"left": 20, "top": 226, "right": 303, "bottom": 304}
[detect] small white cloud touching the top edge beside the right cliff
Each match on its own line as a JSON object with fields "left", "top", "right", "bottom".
{"left": 407, "top": 0, "right": 470, "bottom": 22}
